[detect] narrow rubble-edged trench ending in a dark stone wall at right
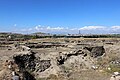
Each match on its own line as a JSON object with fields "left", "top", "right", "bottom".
{"left": 57, "top": 46, "right": 105, "bottom": 65}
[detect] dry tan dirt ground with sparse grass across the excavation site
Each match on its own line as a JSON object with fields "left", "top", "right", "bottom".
{"left": 0, "top": 38, "right": 120, "bottom": 80}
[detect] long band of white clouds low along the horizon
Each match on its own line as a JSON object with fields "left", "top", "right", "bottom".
{"left": 14, "top": 25, "right": 120, "bottom": 34}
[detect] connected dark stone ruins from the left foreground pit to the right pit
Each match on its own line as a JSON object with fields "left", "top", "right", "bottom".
{"left": 0, "top": 43, "right": 105, "bottom": 80}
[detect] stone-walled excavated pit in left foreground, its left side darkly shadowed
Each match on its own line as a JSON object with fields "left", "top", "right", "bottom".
{"left": 13, "top": 52, "right": 51, "bottom": 72}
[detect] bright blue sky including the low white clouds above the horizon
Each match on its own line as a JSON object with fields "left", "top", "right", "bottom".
{"left": 0, "top": 0, "right": 120, "bottom": 33}
